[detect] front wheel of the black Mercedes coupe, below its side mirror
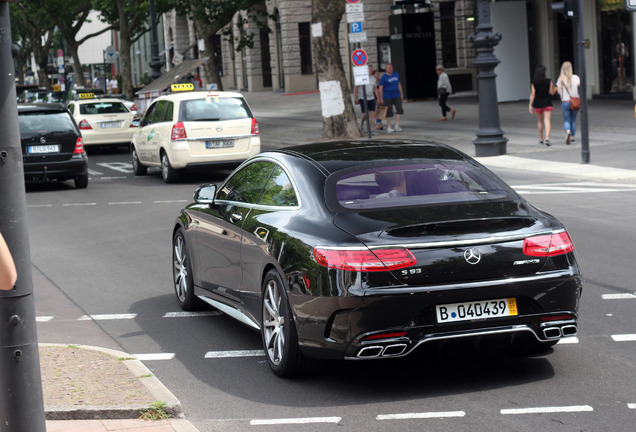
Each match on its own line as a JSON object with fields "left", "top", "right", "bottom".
{"left": 172, "top": 228, "right": 199, "bottom": 311}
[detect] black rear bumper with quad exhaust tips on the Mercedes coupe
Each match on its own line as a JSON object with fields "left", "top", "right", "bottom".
{"left": 290, "top": 272, "right": 582, "bottom": 359}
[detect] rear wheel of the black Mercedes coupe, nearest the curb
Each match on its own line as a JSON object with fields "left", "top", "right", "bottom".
{"left": 261, "top": 270, "right": 311, "bottom": 377}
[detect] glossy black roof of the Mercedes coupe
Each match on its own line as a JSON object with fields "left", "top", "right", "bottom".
{"left": 273, "top": 139, "right": 468, "bottom": 173}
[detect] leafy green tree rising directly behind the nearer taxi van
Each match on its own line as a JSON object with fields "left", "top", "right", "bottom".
{"left": 175, "top": 0, "right": 269, "bottom": 90}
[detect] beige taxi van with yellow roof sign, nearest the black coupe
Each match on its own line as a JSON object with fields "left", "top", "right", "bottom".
{"left": 130, "top": 84, "right": 261, "bottom": 183}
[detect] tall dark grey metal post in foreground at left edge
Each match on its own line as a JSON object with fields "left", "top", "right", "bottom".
{"left": 0, "top": 1, "right": 46, "bottom": 432}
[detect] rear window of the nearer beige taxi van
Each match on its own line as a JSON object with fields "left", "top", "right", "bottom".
{"left": 179, "top": 96, "right": 252, "bottom": 121}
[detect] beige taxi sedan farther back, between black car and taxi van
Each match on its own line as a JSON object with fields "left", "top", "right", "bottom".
{"left": 67, "top": 93, "right": 138, "bottom": 147}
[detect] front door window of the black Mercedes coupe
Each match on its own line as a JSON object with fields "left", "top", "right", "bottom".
{"left": 216, "top": 161, "right": 274, "bottom": 204}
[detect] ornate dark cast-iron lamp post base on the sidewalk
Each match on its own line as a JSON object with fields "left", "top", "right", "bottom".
{"left": 470, "top": 0, "right": 508, "bottom": 156}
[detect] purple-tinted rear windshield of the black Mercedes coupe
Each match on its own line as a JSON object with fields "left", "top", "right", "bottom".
{"left": 327, "top": 161, "right": 511, "bottom": 210}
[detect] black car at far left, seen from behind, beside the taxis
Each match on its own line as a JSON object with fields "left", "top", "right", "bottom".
{"left": 18, "top": 103, "right": 88, "bottom": 189}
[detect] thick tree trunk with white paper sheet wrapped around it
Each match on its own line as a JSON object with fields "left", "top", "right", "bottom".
{"left": 311, "top": 0, "right": 360, "bottom": 139}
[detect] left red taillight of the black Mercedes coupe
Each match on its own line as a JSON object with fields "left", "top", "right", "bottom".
{"left": 314, "top": 248, "right": 416, "bottom": 271}
